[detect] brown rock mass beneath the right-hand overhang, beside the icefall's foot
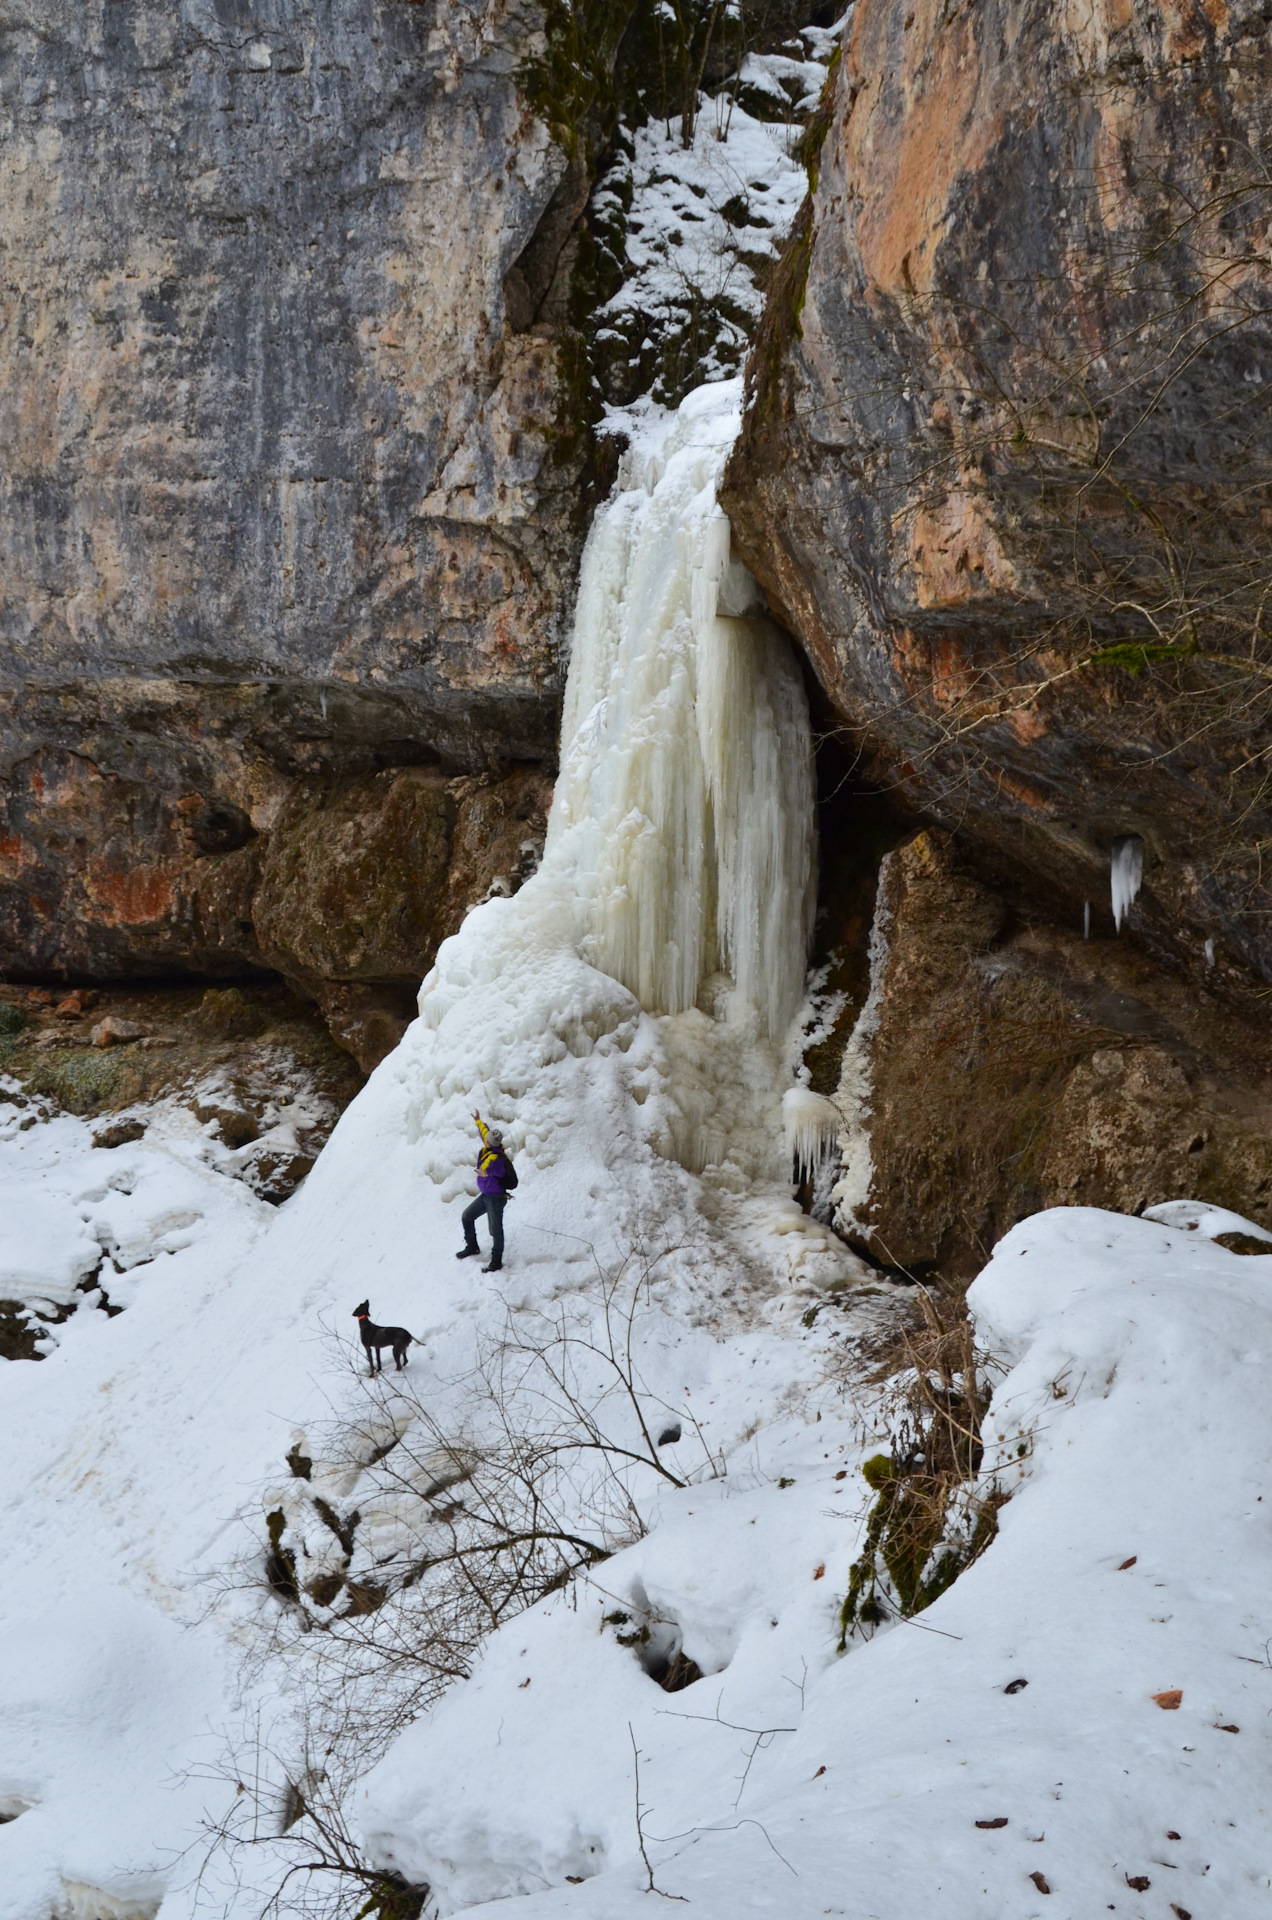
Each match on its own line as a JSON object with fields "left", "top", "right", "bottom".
{"left": 842, "top": 831, "right": 1272, "bottom": 1281}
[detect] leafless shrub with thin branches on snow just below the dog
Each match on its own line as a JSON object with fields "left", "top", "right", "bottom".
{"left": 197, "top": 1244, "right": 724, "bottom": 1920}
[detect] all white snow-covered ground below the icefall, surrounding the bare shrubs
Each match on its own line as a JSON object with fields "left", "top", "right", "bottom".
{"left": 9, "top": 1052, "right": 1272, "bottom": 1920}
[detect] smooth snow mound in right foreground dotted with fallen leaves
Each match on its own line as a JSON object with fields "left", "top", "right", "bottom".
{"left": 361, "top": 1210, "right": 1272, "bottom": 1920}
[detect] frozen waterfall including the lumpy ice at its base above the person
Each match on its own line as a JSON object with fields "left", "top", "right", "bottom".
{"left": 411, "top": 380, "right": 815, "bottom": 1183}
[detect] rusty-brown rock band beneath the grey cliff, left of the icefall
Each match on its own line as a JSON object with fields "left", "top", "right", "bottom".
{"left": 0, "top": 751, "right": 551, "bottom": 1071}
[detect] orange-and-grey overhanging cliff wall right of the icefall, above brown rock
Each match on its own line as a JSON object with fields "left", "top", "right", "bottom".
{"left": 724, "top": 0, "right": 1272, "bottom": 977}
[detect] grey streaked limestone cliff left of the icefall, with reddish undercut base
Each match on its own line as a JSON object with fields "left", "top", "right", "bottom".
{"left": 0, "top": 0, "right": 586, "bottom": 1013}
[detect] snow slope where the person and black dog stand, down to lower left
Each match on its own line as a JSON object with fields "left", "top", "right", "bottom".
{"left": 0, "top": 960, "right": 868, "bottom": 1920}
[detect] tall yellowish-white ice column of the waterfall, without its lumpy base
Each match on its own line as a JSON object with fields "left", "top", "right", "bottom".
{"left": 548, "top": 382, "right": 815, "bottom": 1035}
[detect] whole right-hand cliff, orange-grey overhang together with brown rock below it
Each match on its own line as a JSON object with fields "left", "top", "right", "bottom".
{"left": 724, "top": 0, "right": 1272, "bottom": 1275}
